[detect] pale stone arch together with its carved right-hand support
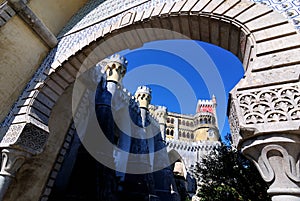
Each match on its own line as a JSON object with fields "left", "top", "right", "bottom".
{"left": 0, "top": 0, "right": 300, "bottom": 200}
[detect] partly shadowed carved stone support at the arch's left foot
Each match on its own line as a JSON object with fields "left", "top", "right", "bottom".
{"left": 0, "top": 123, "right": 49, "bottom": 200}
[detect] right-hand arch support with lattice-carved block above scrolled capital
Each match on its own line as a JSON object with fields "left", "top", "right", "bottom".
{"left": 229, "top": 83, "right": 300, "bottom": 201}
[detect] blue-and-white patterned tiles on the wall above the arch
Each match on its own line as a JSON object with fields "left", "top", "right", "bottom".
{"left": 57, "top": 0, "right": 300, "bottom": 62}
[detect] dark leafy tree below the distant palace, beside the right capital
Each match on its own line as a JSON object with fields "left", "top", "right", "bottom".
{"left": 194, "top": 135, "right": 271, "bottom": 201}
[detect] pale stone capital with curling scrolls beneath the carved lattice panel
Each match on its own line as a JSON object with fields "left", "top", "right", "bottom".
{"left": 242, "top": 134, "right": 300, "bottom": 200}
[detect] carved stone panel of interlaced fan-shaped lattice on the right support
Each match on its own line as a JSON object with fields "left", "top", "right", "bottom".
{"left": 237, "top": 84, "right": 300, "bottom": 125}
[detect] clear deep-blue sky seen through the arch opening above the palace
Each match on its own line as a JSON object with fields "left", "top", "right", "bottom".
{"left": 120, "top": 40, "right": 244, "bottom": 141}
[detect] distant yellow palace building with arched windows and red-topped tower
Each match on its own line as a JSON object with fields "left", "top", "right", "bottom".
{"left": 149, "top": 96, "right": 220, "bottom": 142}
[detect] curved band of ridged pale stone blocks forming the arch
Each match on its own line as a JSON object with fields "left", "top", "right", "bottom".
{"left": 2, "top": 0, "right": 300, "bottom": 146}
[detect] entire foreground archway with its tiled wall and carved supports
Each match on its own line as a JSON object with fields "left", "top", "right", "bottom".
{"left": 0, "top": 0, "right": 300, "bottom": 201}
